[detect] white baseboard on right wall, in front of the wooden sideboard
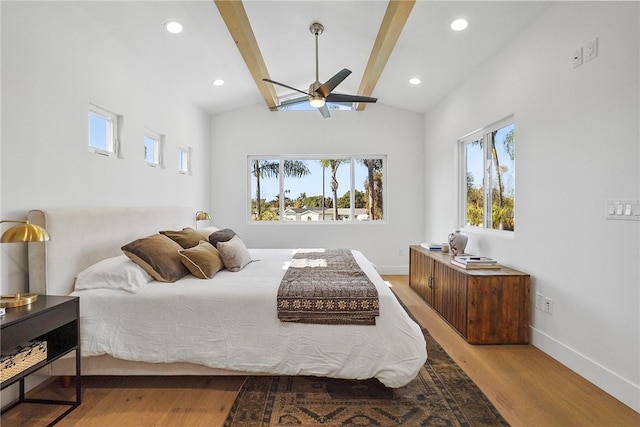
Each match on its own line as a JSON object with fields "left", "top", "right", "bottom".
{"left": 529, "top": 327, "right": 640, "bottom": 412}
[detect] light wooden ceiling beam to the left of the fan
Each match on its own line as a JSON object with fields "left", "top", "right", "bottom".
{"left": 214, "top": 0, "right": 278, "bottom": 111}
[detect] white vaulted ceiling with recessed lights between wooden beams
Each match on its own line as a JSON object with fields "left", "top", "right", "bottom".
{"left": 77, "top": 0, "right": 552, "bottom": 114}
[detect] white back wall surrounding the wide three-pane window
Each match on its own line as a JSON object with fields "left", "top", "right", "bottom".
{"left": 210, "top": 104, "right": 424, "bottom": 274}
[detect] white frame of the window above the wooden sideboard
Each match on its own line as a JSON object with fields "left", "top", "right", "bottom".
{"left": 457, "top": 115, "right": 516, "bottom": 237}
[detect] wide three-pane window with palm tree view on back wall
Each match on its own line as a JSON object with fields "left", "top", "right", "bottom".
{"left": 248, "top": 156, "right": 386, "bottom": 223}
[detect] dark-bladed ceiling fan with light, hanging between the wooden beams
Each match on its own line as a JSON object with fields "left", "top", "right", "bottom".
{"left": 262, "top": 22, "right": 378, "bottom": 119}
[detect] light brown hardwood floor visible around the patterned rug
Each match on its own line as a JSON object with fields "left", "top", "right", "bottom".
{"left": 2, "top": 276, "right": 640, "bottom": 427}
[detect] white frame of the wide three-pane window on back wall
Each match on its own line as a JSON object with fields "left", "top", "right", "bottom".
{"left": 246, "top": 154, "right": 388, "bottom": 225}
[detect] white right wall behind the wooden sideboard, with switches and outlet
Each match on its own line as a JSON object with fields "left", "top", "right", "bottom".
{"left": 425, "top": 2, "right": 640, "bottom": 411}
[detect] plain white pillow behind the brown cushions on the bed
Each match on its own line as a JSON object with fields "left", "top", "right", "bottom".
{"left": 75, "top": 255, "right": 153, "bottom": 294}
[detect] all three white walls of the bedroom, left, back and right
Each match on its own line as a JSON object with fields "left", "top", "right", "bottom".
{"left": 0, "top": 2, "right": 640, "bottom": 416}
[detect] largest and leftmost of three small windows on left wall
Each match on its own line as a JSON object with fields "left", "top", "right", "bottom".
{"left": 89, "top": 104, "right": 122, "bottom": 157}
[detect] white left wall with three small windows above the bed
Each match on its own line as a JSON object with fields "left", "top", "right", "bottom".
{"left": 1, "top": 2, "right": 209, "bottom": 294}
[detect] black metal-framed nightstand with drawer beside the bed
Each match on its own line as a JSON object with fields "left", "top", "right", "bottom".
{"left": 0, "top": 295, "right": 82, "bottom": 426}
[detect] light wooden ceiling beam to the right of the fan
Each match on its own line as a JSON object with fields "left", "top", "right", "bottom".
{"left": 356, "top": 0, "right": 415, "bottom": 111}
